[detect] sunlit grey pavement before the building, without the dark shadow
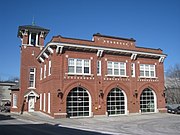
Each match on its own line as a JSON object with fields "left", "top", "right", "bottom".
{"left": 0, "top": 112, "right": 180, "bottom": 135}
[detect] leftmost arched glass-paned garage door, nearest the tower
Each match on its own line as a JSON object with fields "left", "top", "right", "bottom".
{"left": 66, "top": 87, "right": 91, "bottom": 117}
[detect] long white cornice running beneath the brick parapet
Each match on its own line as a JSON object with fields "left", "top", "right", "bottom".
{"left": 37, "top": 42, "right": 166, "bottom": 59}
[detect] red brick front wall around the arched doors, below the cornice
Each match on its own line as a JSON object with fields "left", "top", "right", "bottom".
{"left": 40, "top": 46, "right": 165, "bottom": 116}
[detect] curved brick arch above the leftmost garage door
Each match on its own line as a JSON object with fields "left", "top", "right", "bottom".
{"left": 63, "top": 81, "right": 94, "bottom": 102}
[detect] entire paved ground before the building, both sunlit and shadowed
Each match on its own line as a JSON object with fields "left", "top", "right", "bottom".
{"left": 0, "top": 112, "right": 180, "bottom": 135}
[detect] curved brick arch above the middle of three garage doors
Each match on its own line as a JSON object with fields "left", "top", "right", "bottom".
{"left": 104, "top": 82, "right": 129, "bottom": 99}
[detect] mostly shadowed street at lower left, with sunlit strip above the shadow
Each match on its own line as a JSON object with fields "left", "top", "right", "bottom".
{"left": 0, "top": 114, "right": 108, "bottom": 135}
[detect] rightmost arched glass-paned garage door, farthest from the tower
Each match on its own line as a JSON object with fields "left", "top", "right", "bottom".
{"left": 140, "top": 88, "right": 155, "bottom": 113}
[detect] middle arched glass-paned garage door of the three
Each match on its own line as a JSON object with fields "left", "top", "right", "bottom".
{"left": 107, "top": 88, "right": 126, "bottom": 116}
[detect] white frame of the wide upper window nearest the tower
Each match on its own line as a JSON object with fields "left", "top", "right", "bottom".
{"left": 68, "top": 58, "right": 91, "bottom": 75}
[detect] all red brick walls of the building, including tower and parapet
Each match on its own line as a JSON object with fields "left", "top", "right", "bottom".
{"left": 18, "top": 31, "right": 165, "bottom": 117}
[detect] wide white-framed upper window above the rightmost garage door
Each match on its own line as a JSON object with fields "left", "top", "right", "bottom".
{"left": 140, "top": 64, "right": 156, "bottom": 78}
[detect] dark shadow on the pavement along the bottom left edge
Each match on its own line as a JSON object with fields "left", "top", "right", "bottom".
{"left": 0, "top": 124, "right": 109, "bottom": 135}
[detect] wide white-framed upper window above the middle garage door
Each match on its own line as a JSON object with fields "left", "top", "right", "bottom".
{"left": 107, "top": 61, "right": 126, "bottom": 76}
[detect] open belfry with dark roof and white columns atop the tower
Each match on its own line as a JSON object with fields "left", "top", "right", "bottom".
{"left": 17, "top": 25, "right": 49, "bottom": 47}
